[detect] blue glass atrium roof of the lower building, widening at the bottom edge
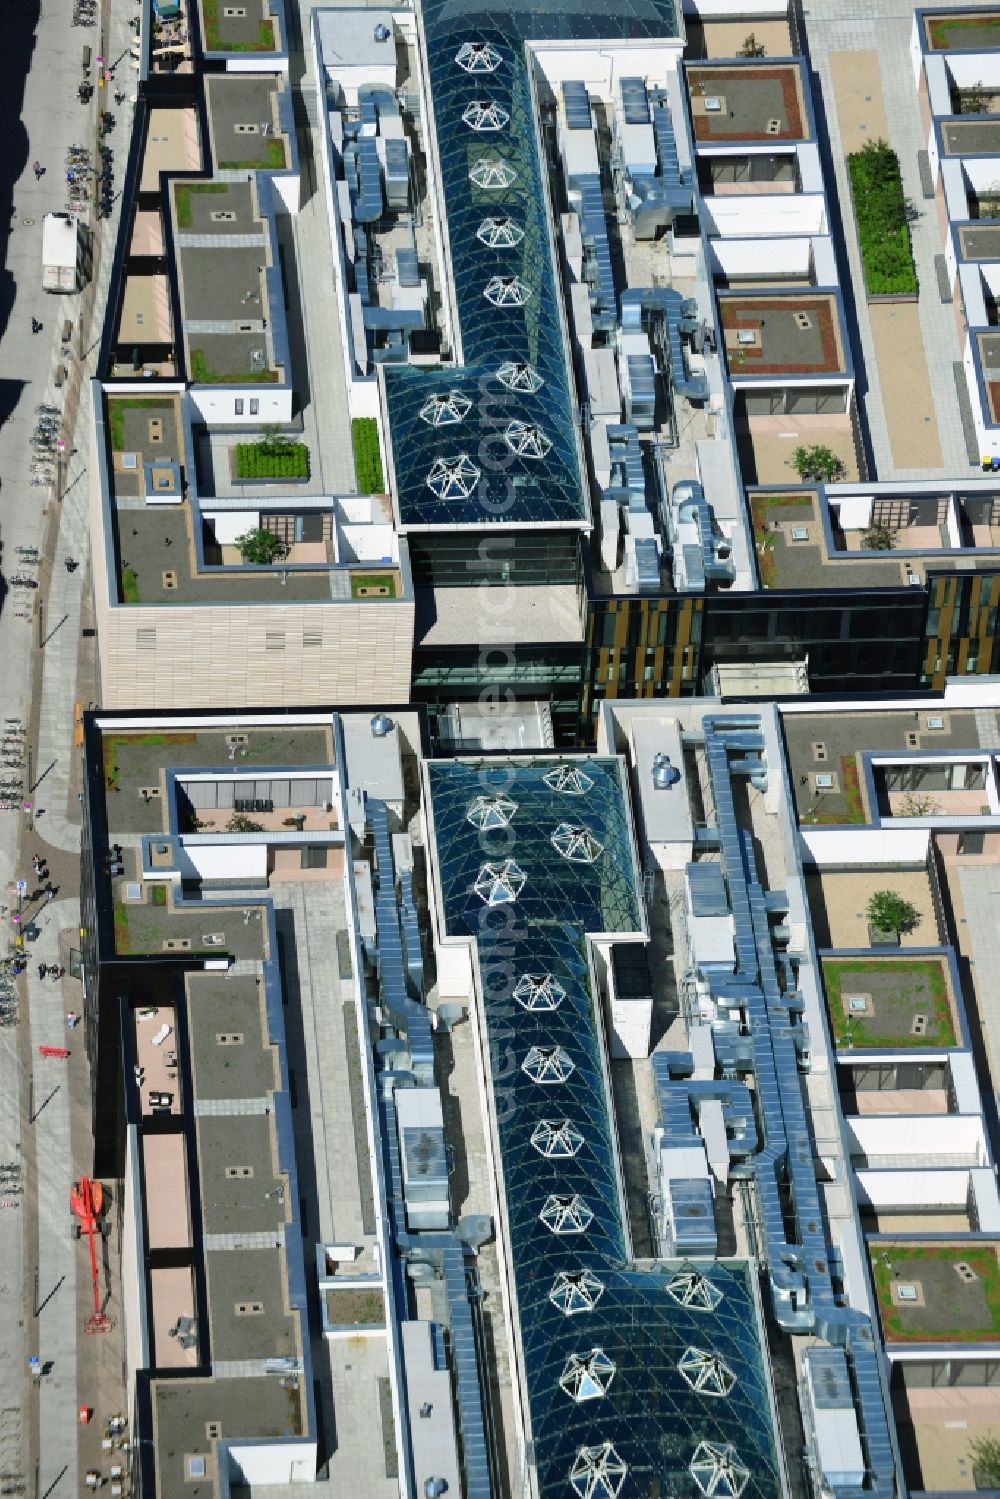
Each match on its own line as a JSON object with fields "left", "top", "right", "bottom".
{"left": 427, "top": 757, "right": 781, "bottom": 1499}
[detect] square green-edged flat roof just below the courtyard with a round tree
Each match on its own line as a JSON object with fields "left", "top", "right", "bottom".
{"left": 823, "top": 956, "right": 958, "bottom": 1051}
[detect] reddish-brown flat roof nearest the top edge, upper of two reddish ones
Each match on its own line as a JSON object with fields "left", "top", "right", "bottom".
{"left": 685, "top": 61, "right": 811, "bottom": 145}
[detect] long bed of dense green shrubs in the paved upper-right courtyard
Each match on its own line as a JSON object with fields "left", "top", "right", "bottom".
{"left": 847, "top": 141, "right": 918, "bottom": 301}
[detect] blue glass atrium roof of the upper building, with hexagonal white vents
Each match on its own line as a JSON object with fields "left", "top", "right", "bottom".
{"left": 384, "top": 0, "right": 678, "bottom": 528}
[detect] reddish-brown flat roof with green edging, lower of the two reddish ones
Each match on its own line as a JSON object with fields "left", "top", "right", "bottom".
{"left": 718, "top": 292, "right": 847, "bottom": 378}
